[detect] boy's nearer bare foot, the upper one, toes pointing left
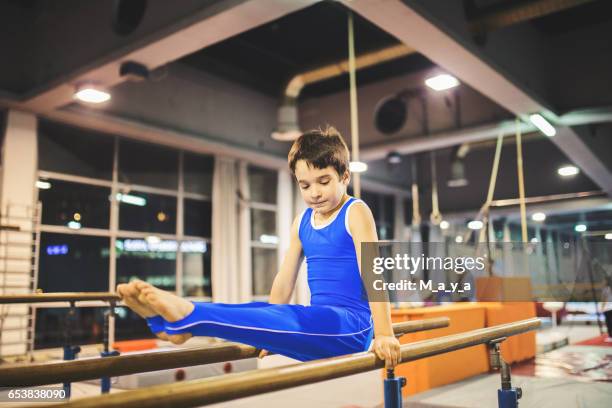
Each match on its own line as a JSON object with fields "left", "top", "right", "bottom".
{"left": 135, "top": 281, "right": 194, "bottom": 344}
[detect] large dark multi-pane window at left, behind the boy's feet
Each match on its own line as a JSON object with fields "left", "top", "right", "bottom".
{"left": 35, "top": 120, "right": 214, "bottom": 348}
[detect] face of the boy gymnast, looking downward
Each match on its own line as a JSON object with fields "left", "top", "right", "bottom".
{"left": 295, "top": 160, "right": 350, "bottom": 214}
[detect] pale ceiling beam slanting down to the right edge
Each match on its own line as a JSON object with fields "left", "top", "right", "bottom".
{"left": 343, "top": 0, "right": 612, "bottom": 194}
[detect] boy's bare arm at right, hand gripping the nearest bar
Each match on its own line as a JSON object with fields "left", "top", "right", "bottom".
{"left": 349, "top": 202, "right": 401, "bottom": 368}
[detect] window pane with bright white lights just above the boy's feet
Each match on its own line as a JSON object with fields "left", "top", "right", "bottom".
{"left": 115, "top": 238, "right": 178, "bottom": 291}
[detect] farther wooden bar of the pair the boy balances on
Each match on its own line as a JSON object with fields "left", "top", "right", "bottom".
{"left": 0, "top": 317, "right": 449, "bottom": 387}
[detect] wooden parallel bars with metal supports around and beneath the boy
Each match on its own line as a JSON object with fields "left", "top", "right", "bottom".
{"left": 0, "top": 293, "right": 540, "bottom": 408}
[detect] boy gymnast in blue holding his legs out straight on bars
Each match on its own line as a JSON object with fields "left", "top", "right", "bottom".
{"left": 117, "top": 128, "right": 400, "bottom": 367}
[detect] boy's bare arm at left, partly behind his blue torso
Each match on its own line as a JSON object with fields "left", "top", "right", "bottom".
{"left": 269, "top": 217, "right": 302, "bottom": 304}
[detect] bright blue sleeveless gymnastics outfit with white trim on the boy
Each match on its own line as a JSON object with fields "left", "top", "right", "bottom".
{"left": 147, "top": 197, "right": 373, "bottom": 361}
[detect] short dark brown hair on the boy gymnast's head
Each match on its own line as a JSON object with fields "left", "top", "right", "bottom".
{"left": 288, "top": 126, "right": 349, "bottom": 177}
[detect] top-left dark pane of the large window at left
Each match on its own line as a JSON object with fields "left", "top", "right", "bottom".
{"left": 38, "top": 120, "right": 115, "bottom": 180}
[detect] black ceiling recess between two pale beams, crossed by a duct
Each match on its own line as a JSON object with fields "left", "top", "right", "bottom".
{"left": 179, "top": 1, "right": 434, "bottom": 97}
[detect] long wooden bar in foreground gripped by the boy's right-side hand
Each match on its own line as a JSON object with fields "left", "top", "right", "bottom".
{"left": 38, "top": 319, "right": 540, "bottom": 408}
